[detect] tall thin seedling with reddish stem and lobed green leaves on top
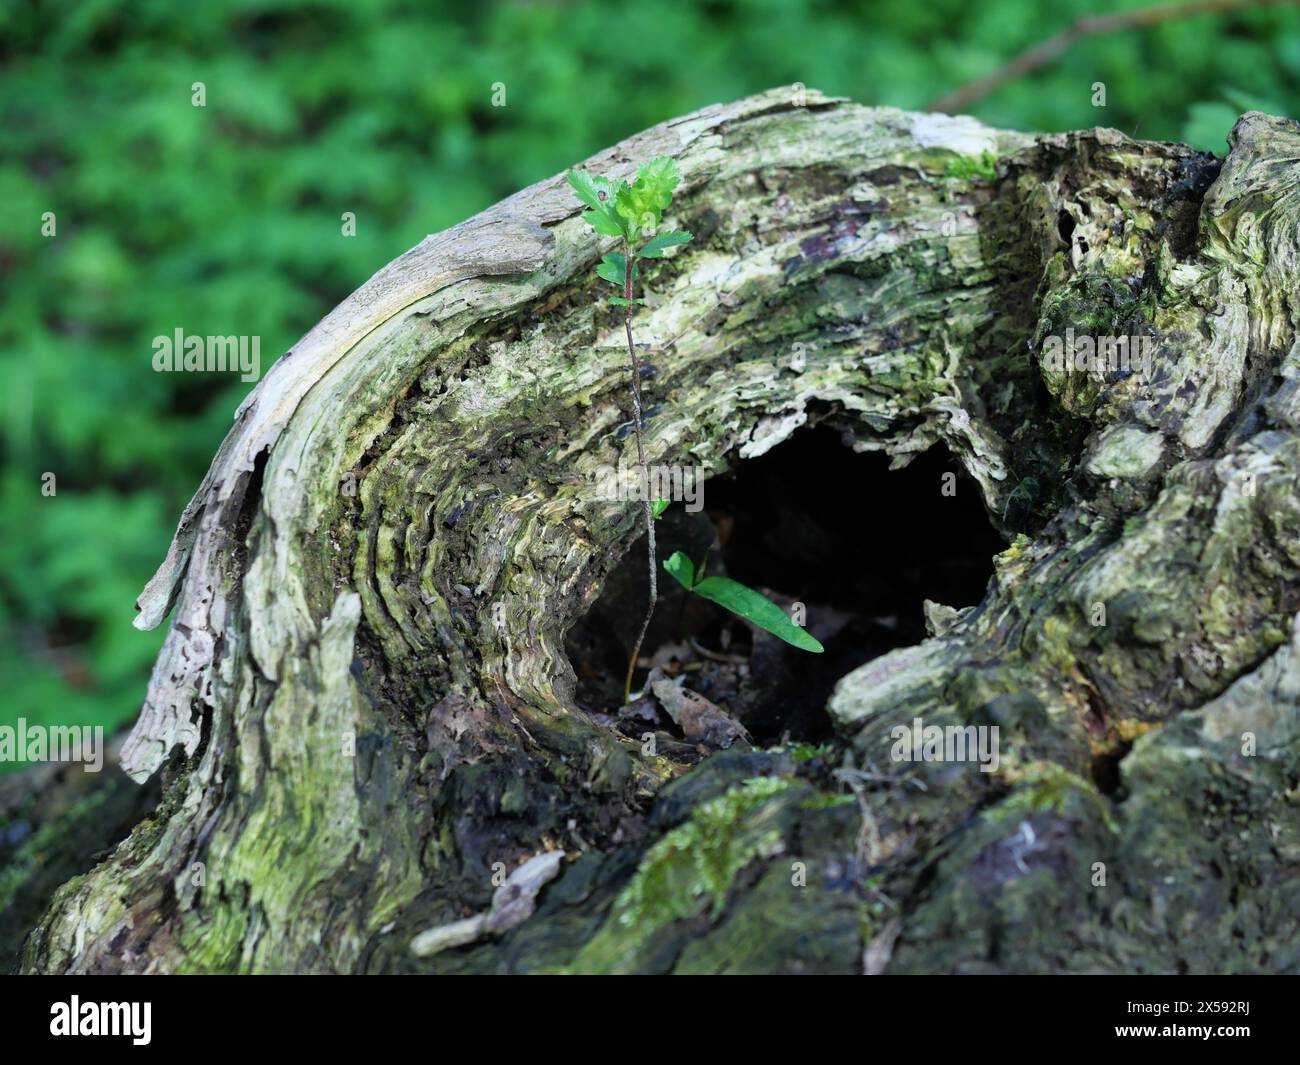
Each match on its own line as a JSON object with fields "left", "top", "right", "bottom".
{"left": 568, "top": 156, "right": 690, "bottom": 702}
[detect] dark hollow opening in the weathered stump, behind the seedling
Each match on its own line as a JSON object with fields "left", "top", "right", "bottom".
{"left": 567, "top": 427, "right": 1005, "bottom": 746}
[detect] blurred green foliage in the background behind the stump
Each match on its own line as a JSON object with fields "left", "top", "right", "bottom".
{"left": 0, "top": 0, "right": 1300, "bottom": 764}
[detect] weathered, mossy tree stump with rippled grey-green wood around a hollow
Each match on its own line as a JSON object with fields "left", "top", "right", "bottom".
{"left": 10, "top": 91, "right": 1300, "bottom": 973}
